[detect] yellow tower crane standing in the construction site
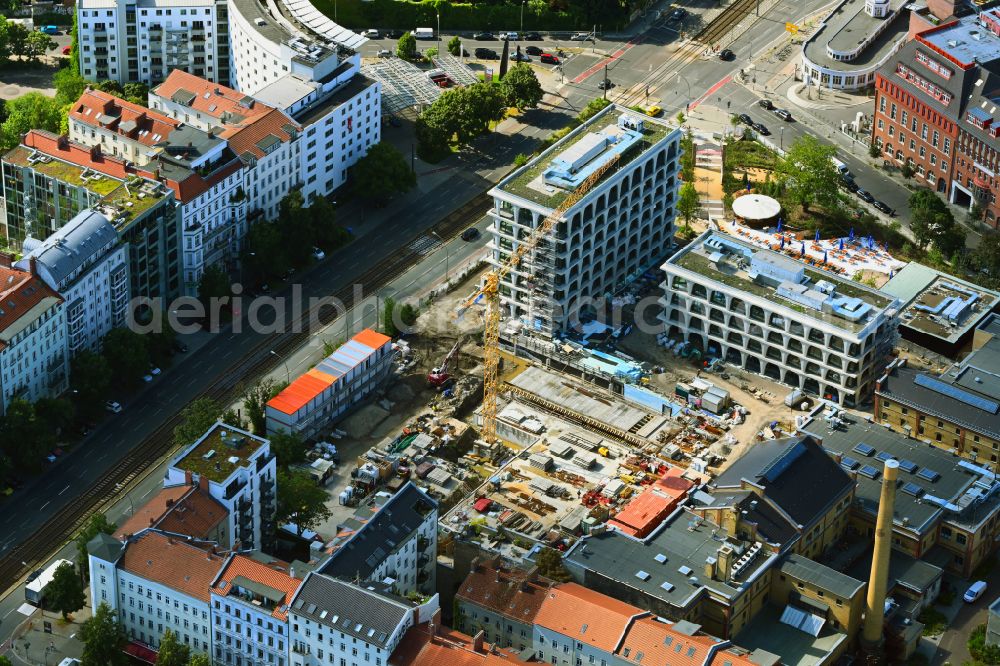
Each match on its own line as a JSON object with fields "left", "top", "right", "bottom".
{"left": 460, "top": 155, "right": 618, "bottom": 444}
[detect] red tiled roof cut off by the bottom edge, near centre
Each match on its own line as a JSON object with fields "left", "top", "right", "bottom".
{"left": 389, "top": 623, "right": 528, "bottom": 666}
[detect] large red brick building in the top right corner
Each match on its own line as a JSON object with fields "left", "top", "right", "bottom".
{"left": 873, "top": 3, "right": 1000, "bottom": 226}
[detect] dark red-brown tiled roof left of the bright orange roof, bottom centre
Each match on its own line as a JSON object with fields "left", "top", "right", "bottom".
{"left": 455, "top": 562, "right": 552, "bottom": 624}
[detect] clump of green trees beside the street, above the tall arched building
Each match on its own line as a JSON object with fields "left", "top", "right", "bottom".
{"left": 416, "top": 63, "right": 542, "bottom": 162}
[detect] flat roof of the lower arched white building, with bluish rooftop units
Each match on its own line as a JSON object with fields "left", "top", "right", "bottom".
{"left": 667, "top": 232, "right": 895, "bottom": 333}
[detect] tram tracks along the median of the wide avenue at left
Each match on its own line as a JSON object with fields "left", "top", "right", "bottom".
{"left": 0, "top": 192, "right": 491, "bottom": 590}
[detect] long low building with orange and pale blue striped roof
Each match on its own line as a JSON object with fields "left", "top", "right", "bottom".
{"left": 264, "top": 328, "right": 396, "bottom": 439}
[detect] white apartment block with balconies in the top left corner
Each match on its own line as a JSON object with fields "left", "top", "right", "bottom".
{"left": 76, "top": 0, "right": 230, "bottom": 84}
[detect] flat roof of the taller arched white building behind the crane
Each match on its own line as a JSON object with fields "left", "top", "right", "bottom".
{"left": 497, "top": 105, "right": 675, "bottom": 208}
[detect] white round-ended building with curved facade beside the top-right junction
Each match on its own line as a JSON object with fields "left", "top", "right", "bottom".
{"left": 802, "top": 0, "right": 909, "bottom": 91}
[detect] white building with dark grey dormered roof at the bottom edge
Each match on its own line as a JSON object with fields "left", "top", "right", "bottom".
{"left": 289, "top": 573, "right": 439, "bottom": 666}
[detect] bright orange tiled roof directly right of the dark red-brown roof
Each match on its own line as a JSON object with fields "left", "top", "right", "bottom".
{"left": 535, "top": 583, "right": 647, "bottom": 652}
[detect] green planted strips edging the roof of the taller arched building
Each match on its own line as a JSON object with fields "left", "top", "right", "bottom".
{"left": 500, "top": 111, "right": 673, "bottom": 208}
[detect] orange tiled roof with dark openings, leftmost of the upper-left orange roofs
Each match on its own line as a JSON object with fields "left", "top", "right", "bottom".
{"left": 69, "top": 88, "right": 181, "bottom": 146}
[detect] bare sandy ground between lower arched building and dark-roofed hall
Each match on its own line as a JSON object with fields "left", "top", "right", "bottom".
{"left": 620, "top": 328, "right": 802, "bottom": 469}
